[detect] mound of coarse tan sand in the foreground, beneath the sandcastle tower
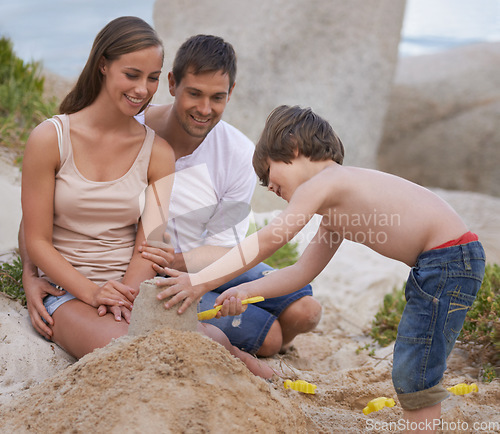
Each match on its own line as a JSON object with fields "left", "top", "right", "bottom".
{"left": 0, "top": 328, "right": 306, "bottom": 433}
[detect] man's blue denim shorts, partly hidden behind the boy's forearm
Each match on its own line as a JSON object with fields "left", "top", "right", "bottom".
{"left": 198, "top": 262, "right": 312, "bottom": 354}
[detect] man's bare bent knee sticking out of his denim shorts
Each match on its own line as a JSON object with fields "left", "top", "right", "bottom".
{"left": 278, "top": 295, "right": 322, "bottom": 333}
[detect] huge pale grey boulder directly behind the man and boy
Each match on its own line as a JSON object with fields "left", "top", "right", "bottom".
{"left": 154, "top": 0, "right": 405, "bottom": 167}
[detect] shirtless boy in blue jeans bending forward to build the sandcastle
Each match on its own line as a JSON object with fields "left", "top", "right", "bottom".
{"left": 159, "top": 106, "right": 485, "bottom": 427}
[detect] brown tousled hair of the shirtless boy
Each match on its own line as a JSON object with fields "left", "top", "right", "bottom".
{"left": 253, "top": 105, "right": 344, "bottom": 186}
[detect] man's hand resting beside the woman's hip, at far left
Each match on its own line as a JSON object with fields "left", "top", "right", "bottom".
{"left": 23, "top": 275, "right": 66, "bottom": 340}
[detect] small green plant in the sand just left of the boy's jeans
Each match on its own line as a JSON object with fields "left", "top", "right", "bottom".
{"left": 370, "top": 284, "right": 406, "bottom": 347}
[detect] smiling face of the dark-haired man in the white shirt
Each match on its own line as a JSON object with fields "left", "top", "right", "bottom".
{"left": 168, "top": 70, "right": 234, "bottom": 139}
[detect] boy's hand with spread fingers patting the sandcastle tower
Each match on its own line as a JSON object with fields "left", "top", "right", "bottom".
{"left": 155, "top": 267, "right": 206, "bottom": 314}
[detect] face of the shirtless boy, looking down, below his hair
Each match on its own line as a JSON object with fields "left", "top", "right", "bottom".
{"left": 267, "top": 155, "right": 305, "bottom": 202}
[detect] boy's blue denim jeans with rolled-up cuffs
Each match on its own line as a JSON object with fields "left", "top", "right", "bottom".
{"left": 392, "top": 241, "right": 485, "bottom": 410}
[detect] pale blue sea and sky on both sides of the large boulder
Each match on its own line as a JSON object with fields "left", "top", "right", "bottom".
{"left": 0, "top": 0, "right": 500, "bottom": 78}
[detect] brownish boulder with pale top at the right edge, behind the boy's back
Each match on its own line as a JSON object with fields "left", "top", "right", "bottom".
{"left": 378, "top": 43, "right": 500, "bottom": 196}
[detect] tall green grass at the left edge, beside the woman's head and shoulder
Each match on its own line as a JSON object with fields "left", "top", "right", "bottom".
{"left": 0, "top": 37, "right": 57, "bottom": 163}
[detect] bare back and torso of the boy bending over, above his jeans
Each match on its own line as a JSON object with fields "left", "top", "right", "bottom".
{"left": 290, "top": 162, "right": 468, "bottom": 266}
